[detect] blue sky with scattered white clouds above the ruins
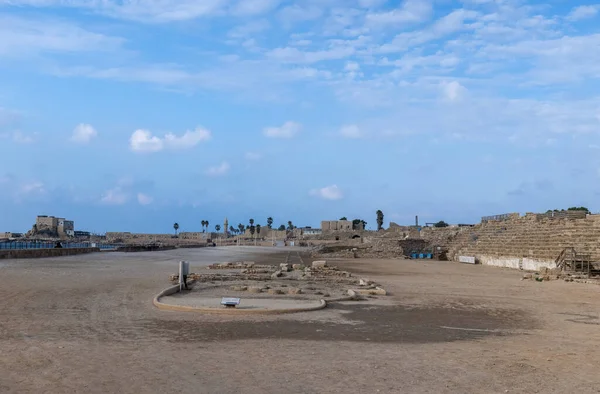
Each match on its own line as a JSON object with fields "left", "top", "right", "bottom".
{"left": 0, "top": 0, "right": 600, "bottom": 233}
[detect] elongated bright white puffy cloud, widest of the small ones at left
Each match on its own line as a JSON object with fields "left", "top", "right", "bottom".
{"left": 129, "top": 127, "right": 211, "bottom": 152}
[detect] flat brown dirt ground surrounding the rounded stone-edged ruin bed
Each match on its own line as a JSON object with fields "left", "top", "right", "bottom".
{"left": 0, "top": 247, "right": 600, "bottom": 394}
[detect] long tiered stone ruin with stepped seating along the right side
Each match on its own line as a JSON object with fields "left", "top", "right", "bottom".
{"left": 312, "top": 211, "right": 600, "bottom": 277}
